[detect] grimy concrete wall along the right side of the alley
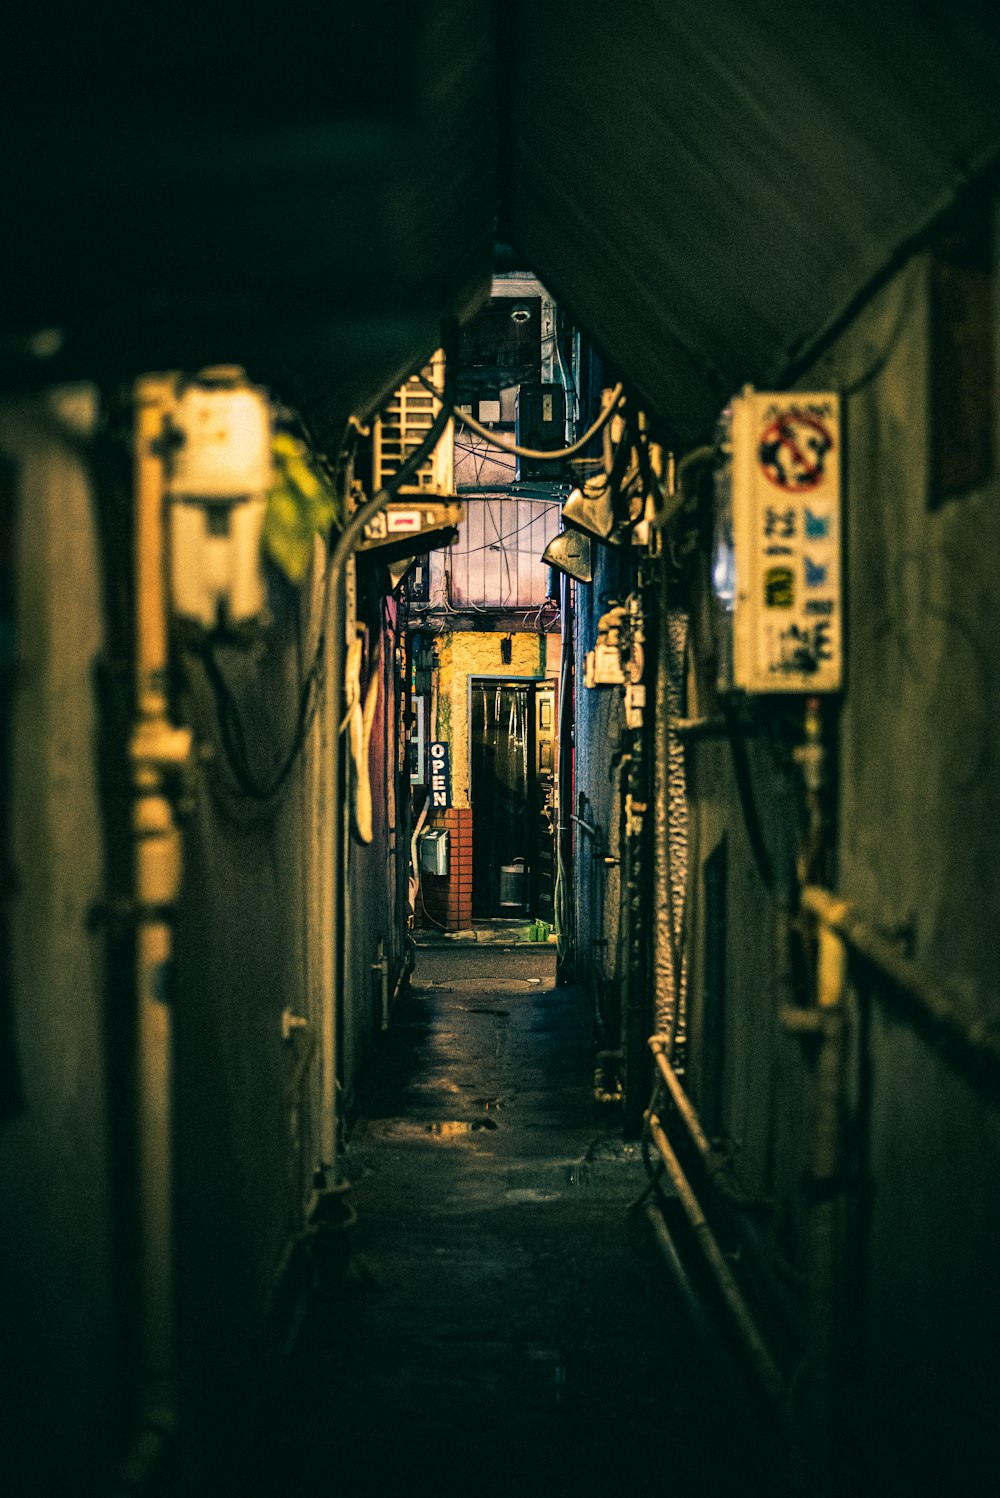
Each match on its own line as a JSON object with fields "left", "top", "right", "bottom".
{"left": 687, "top": 224, "right": 1000, "bottom": 1492}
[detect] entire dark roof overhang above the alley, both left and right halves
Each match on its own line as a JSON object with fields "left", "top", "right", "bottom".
{"left": 0, "top": 0, "right": 1000, "bottom": 448}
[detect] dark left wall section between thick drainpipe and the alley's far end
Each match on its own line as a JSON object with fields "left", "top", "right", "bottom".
{"left": 177, "top": 551, "right": 400, "bottom": 1446}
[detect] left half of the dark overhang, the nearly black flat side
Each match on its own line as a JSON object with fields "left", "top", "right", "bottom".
{"left": 0, "top": 0, "right": 497, "bottom": 448}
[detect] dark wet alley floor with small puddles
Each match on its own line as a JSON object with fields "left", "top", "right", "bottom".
{"left": 236, "top": 945, "right": 778, "bottom": 1498}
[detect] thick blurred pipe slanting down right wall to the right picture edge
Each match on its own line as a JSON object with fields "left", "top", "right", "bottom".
{"left": 801, "top": 885, "right": 1000, "bottom": 1086}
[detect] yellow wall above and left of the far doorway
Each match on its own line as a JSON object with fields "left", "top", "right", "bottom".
{"left": 433, "top": 631, "right": 561, "bottom": 806}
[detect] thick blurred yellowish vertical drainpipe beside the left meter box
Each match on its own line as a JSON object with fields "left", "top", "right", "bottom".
{"left": 123, "top": 376, "right": 192, "bottom": 1486}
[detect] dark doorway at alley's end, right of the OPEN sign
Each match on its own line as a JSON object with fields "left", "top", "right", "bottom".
{"left": 469, "top": 676, "right": 555, "bottom": 921}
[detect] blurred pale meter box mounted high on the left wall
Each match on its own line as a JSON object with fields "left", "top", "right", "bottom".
{"left": 165, "top": 374, "right": 272, "bottom": 629}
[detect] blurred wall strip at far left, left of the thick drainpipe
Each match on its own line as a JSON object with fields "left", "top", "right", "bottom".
{"left": 0, "top": 388, "right": 123, "bottom": 1494}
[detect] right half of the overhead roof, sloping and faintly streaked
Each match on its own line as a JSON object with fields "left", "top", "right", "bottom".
{"left": 507, "top": 0, "right": 1000, "bottom": 445}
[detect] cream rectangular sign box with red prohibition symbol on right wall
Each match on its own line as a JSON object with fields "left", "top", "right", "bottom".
{"left": 713, "top": 389, "right": 843, "bottom": 694}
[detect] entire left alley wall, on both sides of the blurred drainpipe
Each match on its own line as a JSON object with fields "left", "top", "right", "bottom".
{"left": 0, "top": 389, "right": 401, "bottom": 1498}
